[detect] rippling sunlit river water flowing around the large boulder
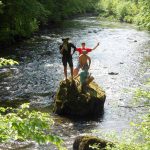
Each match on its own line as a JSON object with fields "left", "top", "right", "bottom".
{"left": 0, "top": 17, "right": 150, "bottom": 150}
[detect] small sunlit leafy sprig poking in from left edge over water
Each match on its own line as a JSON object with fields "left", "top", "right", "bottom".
{"left": 0, "top": 58, "right": 19, "bottom": 67}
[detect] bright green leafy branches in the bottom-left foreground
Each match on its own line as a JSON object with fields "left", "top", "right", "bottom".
{"left": 0, "top": 104, "right": 63, "bottom": 150}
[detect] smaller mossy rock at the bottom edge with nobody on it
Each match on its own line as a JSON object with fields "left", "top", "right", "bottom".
{"left": 73, "top": 136, "right": 114, "bottom": 150}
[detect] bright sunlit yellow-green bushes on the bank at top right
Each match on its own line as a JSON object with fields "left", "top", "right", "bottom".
{"left": 98, "top": 0, "right": 150, "bottom": 30}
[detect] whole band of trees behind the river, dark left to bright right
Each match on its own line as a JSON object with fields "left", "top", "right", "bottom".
{"left": 0, "top": 0, "right": 150, "bottom": 44}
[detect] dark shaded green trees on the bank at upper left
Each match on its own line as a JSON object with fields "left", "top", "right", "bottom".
{"left": 0, "top": 0, "right": 98, "bottom": 43}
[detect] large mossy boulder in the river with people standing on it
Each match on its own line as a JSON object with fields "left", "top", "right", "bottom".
{"left": 54, "top": 78, "right": 106, "bottom": 116}
